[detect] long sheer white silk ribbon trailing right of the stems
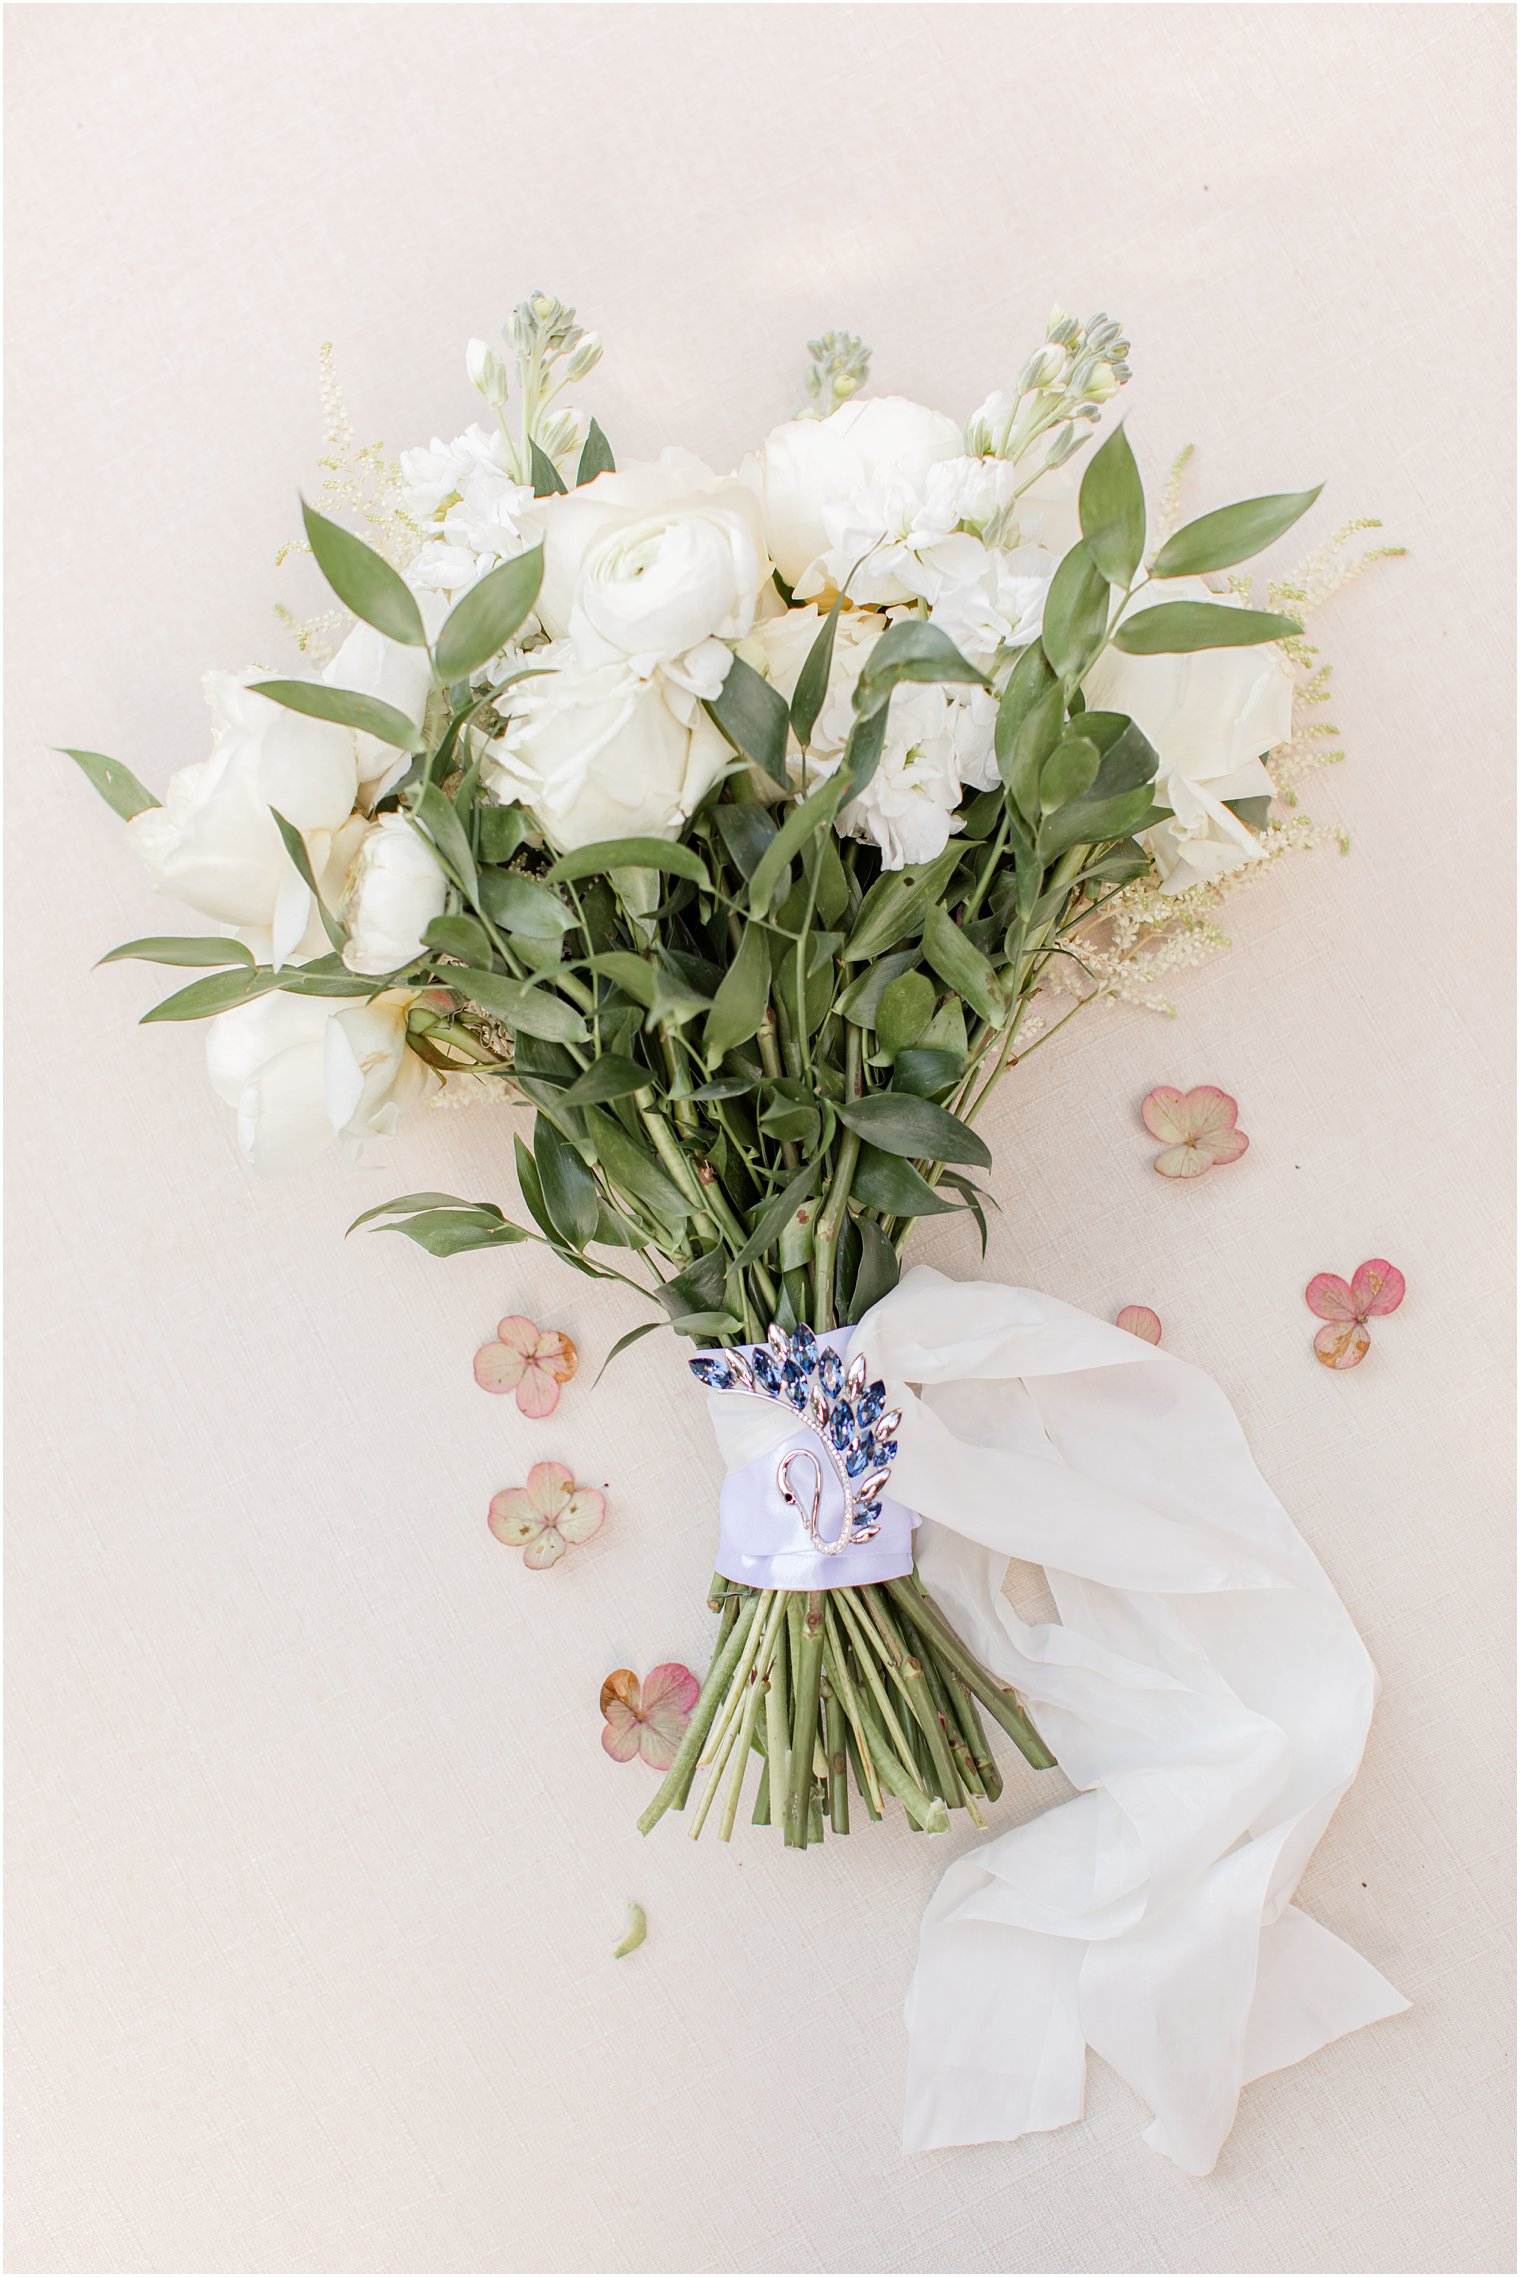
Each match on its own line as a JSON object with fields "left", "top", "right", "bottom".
{"left": 696, "top": 1266, "right": 1409, "bottom": 2175}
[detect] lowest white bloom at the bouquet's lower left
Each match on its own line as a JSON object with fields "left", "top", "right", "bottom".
{"left": 207, "top": 988, "right": 432, "bottom": 1175}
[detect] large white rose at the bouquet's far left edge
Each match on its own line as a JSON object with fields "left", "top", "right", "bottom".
{"left": 127, "top": 672, "right": 357, "bottom": 933}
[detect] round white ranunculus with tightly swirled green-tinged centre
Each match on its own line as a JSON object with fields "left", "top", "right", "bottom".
{"left": 535, "top": 451, "right": 767, "bottom": 692}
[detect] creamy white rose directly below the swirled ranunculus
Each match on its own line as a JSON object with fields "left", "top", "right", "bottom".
{"left": 480, "top": 642, "right": 733, "bottom": 852}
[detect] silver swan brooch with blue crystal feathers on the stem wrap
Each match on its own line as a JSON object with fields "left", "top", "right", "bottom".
{"left": 687, "top": 1321, "right": 901, "bottom": 1557}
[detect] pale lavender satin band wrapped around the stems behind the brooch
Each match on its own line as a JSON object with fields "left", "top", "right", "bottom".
{"left": 703, "top": 1327, "right": 919, "bottom": 1589}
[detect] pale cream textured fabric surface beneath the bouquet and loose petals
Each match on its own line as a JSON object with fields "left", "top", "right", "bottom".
{"left": 7, "top": 5, "right": 1513, "bottom": 2272}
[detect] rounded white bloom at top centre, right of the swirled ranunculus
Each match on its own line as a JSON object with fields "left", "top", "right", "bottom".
{"left": 740, "top": 396, "right": 965, "bottom": 601}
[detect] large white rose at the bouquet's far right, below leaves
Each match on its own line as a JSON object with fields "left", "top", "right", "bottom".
{"left": 1085, "top": 578, "right": 1292, "bottom": 893}
